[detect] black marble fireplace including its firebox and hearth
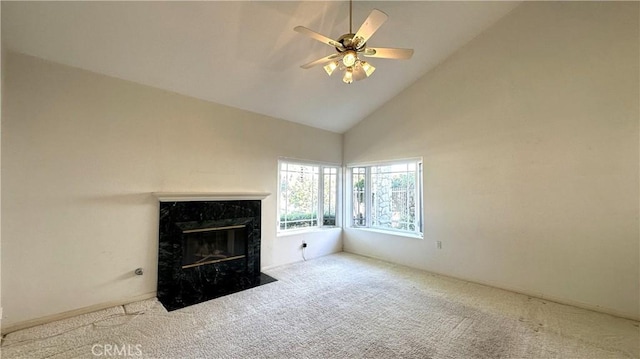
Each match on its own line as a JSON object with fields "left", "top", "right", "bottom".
{"left": 156, "top": 194, "right": 275, "bottom": 311}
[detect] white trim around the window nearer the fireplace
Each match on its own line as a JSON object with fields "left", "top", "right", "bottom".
{"left": 276, "top": 157, "right": 344, "bottom": 237}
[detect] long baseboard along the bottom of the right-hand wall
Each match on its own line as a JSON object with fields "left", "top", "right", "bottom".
{"left": 344, "top": 251, "right": 640, "bottom": 321}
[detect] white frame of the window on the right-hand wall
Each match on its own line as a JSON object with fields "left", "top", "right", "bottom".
{"left": 345, "top": 157, "right": 424, "bottom": 239}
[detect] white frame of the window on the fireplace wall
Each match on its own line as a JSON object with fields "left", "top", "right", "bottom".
{"left": 276, "top": 157, "right": 343, "bottom": 236}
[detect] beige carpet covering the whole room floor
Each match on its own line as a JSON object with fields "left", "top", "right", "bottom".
{"left": 2, "top": 253, "right": 640, "bottom": 359}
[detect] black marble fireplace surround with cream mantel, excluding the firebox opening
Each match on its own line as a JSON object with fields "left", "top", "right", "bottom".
{"left": 154, "top": 192, "right": 275, "bottom": 311}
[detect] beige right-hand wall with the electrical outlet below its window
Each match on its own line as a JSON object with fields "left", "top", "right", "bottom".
{"left": 343, "top": 2, "right": 640, "bottom": 318}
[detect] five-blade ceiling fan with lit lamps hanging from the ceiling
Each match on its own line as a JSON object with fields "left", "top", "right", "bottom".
{"left": 293, "top": 0, "right": 413, "bottom": 84}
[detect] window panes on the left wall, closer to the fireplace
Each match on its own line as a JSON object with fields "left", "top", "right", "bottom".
{"left": 278, "top": 160, "right": 340, "bottom": 231}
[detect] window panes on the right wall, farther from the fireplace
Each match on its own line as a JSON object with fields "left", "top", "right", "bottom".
{"left": 351, "top": 160, "right": 422, "bottom": 235}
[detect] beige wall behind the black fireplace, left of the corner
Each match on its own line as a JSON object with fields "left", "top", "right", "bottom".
{"left": 2, "top": 54, "right": 342, "bottom": 327}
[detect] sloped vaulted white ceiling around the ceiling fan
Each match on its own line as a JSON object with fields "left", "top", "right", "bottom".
{"left": 2, "top": 1, "right": 519, "bottom": 133}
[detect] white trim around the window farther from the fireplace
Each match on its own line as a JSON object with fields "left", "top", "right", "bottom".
{"left": 344, "top": 157, "right": 424, "bottom": 239}
